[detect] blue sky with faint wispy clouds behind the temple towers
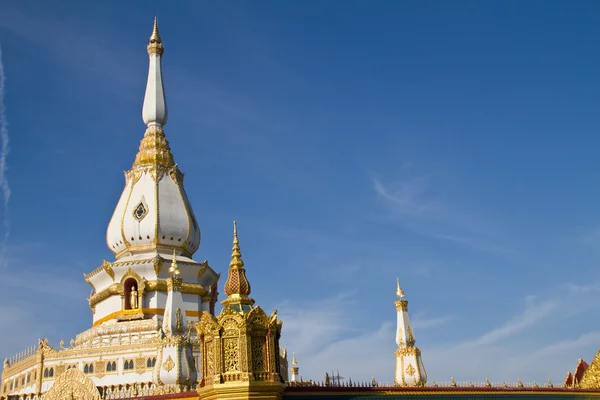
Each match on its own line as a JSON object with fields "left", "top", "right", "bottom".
{"left": 0, "top": 0, "right": 600, "bottom": 382}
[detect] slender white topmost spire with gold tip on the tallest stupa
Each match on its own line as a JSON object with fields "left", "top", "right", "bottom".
{"left": 142, "top": 17, "right": 168, "bottom": 127}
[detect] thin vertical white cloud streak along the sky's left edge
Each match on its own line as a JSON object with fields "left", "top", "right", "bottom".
{"left": 0, "top": 46, "right": 10, "bottom": 268}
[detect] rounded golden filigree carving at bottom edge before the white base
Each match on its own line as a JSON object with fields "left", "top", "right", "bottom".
{"left": 44, "top": 368, "right": 101, "bottom": 400}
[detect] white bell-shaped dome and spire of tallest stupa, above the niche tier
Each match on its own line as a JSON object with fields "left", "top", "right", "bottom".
{"left": 106, "top": 20, "right": 200, "bottom": 260}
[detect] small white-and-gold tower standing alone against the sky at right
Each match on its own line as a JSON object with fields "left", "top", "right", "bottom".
{"left": 394, "top": 280, "right": 427, "bottom": 386}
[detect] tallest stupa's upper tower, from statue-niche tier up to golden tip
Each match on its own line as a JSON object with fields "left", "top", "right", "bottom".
{"left": 85, "top": 19, "right": 218, "bottom": 330}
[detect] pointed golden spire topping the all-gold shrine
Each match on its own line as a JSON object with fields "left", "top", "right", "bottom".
{"left": 221, "top": 221, "right": 254, "bottom": 311}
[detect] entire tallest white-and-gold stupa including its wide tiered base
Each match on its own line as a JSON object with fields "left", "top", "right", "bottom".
{"left": 0, "top": 19, "right": 219, "bottom": 400}
